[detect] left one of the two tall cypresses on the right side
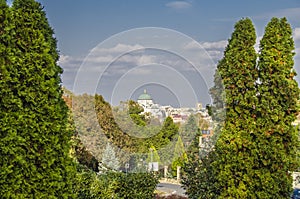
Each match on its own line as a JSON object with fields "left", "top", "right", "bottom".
{"left": 213, "top": 18, "right": 257, "bottom": 198}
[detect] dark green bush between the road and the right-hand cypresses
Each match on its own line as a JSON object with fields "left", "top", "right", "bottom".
{"left": 181, "top": 124, "right": 220, "bottom": 199}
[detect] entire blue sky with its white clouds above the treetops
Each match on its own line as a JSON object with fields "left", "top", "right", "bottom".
{"left": 11, "top": 0, "right": 300, "bottom": 106}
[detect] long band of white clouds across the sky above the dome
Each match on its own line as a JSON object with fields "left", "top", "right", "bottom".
{"left": 60, "top": 41, "right": 220, "bottom": 94}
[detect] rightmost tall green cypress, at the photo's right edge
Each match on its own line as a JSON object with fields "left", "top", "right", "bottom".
{"left": 257, "top": 18, "right": 299, "bottom": 198}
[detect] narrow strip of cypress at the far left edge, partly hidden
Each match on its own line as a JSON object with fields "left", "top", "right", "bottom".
{"left": 0, "top": 0, "right": 25, "bottom": 198}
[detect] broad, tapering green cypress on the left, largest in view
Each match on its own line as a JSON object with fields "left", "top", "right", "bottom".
{"left": 0, "top": 0, "right": 75, "bottom": 198}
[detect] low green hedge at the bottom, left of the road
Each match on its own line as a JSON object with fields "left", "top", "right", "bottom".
{"left": 76, "top": 166, "right": 158, "bottom": 199}
